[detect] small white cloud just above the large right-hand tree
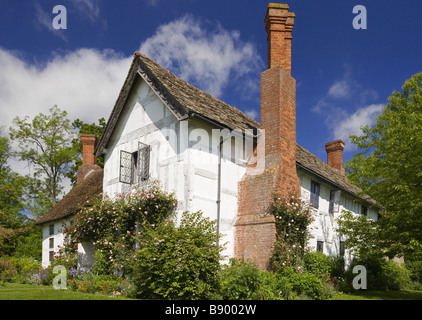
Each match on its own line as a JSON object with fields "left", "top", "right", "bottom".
{"left": 332, "top": 104, "right": 384, "bottom": 150}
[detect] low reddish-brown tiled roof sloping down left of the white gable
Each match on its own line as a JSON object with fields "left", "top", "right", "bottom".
{"left": 36, "top": 169, "right": 104, "bottom": 224}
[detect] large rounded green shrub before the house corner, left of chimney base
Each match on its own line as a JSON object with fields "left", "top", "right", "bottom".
{"left": 132, "top": 212, "right": 221, "bottom": 299}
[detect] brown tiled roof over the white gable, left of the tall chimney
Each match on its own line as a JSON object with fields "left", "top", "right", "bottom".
{"left": 96, "top": 52, "right": 259, "bottom": 156}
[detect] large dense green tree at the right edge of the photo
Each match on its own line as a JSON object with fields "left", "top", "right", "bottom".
{"left": 346, "top": 73, "right": 422, "bottom": 255}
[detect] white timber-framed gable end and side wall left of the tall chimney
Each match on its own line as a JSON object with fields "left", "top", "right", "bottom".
{"left": 103, "top": 80, "right": 248, "bottom": 258}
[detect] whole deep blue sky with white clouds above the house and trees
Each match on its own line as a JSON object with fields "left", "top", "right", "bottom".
{"left": 0, "top": 0, "right": 422, "bottom": 166}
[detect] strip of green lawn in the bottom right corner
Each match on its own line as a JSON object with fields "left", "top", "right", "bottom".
{"left": 331, "top": 290, "right": 422, "bottom": 300}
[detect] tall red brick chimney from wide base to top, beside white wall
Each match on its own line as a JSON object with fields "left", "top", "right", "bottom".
{"left": 235, "top": 3, "right": 300, "bottom": 269}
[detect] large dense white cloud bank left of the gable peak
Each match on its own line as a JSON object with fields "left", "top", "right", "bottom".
{"left": 0, "top": 48, "right": 130, "bottom": 132}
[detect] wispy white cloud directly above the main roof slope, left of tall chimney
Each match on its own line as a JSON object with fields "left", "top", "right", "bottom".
{"left": 140, "top": 15, "right": 263, "bottom": 97}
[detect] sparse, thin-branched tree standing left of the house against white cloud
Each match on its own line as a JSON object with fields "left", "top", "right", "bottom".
{"left": 10, "top": 106, "right": 78, "bottom": 209}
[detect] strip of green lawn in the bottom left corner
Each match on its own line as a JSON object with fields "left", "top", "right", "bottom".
{"left": 0, "top": 283, "right": 132, "bottom": 300}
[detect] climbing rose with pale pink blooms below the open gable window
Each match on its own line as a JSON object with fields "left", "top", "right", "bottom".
{"left": 63, "top": 183, "right": 177, "bottom": 274}
